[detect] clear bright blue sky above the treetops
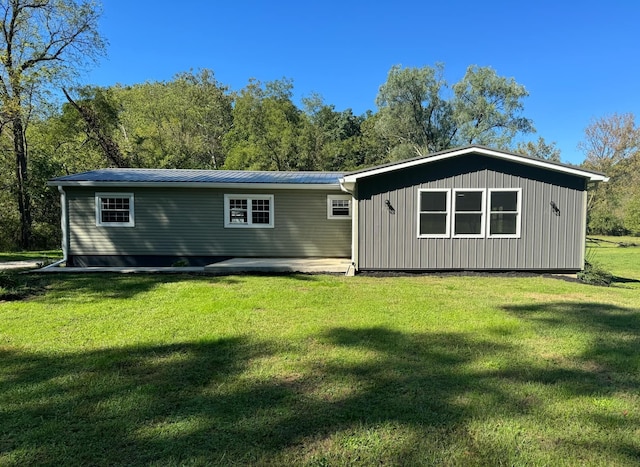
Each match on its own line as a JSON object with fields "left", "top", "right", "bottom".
{"left": 83, "top": 0, "right": 640, "bottom": 163}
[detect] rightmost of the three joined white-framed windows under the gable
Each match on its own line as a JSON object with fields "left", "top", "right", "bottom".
{"left": 487, "top": 188, "right": 522, "bottom": 238}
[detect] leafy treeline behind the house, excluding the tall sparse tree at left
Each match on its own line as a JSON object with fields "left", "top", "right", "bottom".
{"left": 0, "top": 65, "right": 640, "bottom": 250}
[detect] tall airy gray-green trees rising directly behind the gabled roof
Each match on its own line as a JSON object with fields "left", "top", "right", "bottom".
{"left": 376, "top": 64, "right": 535, "bottom": 159}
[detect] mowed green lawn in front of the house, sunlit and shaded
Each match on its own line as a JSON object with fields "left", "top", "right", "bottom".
{"left": 0, "top": 248, "right": 640, "bottom": 465}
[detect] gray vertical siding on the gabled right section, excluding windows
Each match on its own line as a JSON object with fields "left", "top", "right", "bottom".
{"left": 357, "top": 155, "right": 586, "bottom": 270}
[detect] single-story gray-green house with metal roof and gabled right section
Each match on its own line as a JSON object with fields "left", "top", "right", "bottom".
{"left": 49, "top": 146, "right": 608, "bottom": 272}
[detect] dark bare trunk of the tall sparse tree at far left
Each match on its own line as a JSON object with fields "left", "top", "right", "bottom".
{"left": 11, "top": 116, "right": 31, "bottom": 250}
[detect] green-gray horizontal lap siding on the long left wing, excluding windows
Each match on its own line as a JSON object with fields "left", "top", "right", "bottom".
{"left": 67, "top": 188, "right": 351, "bottom": 257}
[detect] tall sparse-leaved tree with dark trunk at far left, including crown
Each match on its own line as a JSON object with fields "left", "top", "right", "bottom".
{"left": 0, "top": 0, "right": 104, "bottom": 248}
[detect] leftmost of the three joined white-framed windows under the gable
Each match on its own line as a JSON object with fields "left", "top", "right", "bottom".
{"left": 418, "top": 189, "right": 451, "bottom": 238}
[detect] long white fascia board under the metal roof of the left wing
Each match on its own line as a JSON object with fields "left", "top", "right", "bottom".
{"left": 47, "top": 180, "right": 341, "bottom": 191}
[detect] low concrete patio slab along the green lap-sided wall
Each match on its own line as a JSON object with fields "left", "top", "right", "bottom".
{"left": 204, "top": 258, "right": 351, "bottom": 274}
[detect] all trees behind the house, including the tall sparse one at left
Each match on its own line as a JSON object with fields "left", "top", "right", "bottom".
{"left": 0, "top": 0, "right": 640, "bottom": 249}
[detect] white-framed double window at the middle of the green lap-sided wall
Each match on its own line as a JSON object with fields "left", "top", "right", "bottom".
{"left": 224, "top": 194, "right": 273, "bottom": 228}
